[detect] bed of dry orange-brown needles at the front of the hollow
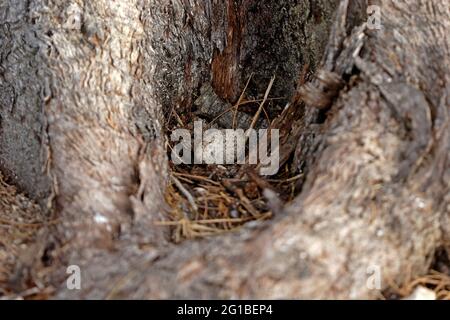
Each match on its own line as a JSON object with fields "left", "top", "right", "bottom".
{"left": 158, "top": 167, "right": 271, "bottom": 242}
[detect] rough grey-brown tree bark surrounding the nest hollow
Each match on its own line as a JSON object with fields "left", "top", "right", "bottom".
{"left": 0, "top": 0, "right": 450, "bottom": 298}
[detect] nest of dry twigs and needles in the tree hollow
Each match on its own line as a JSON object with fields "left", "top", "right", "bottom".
{"left": 158, "top": 78, "right": 303, "bottom": 242}
